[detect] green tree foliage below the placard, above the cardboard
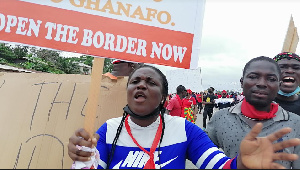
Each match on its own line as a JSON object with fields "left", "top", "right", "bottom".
{"left": 0, "top": 43, "right": 112, "bottom": 74}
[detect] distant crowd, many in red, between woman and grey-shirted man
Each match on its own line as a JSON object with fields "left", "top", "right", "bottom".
{"left": 163, "top": 85, "right": 244, "bottom": 129}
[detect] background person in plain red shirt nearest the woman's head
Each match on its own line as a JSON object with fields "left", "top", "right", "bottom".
{"left": 166, "top": 85, "right": 186, "bottom": 117}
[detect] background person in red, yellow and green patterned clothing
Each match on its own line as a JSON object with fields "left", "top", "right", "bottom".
{"left": 181, "top": 89, "right": 198, "bottom": 123}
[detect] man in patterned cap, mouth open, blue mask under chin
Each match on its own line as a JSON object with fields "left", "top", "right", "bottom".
{"left": 273, "top": 52, "right": 300, "bottom": 115}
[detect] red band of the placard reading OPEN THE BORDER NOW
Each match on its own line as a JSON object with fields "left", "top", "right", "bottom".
{"left": 0, "top": 0, "right": 205, "bottom": 68}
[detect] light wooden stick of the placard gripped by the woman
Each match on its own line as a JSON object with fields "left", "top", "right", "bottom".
{"left": 84, "top": 57, "right": 104, "bottom": 138}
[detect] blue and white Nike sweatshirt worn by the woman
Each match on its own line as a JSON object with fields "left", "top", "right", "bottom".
{"left": 97, "top": 115, "right": 236, "bottom": 169}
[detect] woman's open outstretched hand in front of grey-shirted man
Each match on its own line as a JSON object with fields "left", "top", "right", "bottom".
{"left": 237, "top": 123, "right": 300, "bottom": 169}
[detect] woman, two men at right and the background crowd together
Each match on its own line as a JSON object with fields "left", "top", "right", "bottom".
{"left": 68, "top": 52, "right": 300, "bottom": 169}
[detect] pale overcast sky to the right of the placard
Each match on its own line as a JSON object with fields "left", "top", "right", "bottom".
{"left": 152, "top": 0, "right": 300, "bottom": 90}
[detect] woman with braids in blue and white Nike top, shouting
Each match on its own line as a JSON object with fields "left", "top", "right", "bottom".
{"left": 68, "top": 65, "right": 300, "bottom": 169}
